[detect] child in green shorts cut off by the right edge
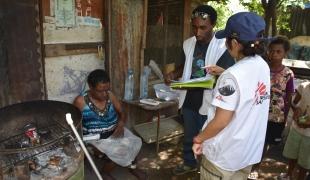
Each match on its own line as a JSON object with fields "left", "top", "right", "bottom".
{"left": 280, "top": 82, "right": 310, "bottom": 180}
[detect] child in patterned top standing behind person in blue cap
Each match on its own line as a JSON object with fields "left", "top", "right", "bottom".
{"left": 265, "top": 36, "right": 294, "bottom": 150}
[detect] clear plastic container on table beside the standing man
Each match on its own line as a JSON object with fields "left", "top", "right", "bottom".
{"left": 153, "top": 83, "right": 179, "bottom": 101}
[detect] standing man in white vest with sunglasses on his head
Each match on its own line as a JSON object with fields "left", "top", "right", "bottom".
{"left": 165, "top": 5, "right": 234, "bottom": 175}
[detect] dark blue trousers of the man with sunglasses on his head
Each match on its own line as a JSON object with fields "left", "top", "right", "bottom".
{"left": 182, "top": 108, "right": 207, "bottom": 167}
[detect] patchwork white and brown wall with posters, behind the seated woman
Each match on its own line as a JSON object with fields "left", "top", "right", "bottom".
{"left": 41, "top": 0, "right": 110, "bottom": 103}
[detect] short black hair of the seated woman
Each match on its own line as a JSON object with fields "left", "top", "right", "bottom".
{"left": 87, "top": 69, "right": 110, "bottom": 87}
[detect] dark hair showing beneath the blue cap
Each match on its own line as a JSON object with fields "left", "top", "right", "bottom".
{"left": 226, "top": 31, "right": 266, "bottom": 56}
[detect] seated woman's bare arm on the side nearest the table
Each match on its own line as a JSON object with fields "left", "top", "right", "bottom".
{"left": 109, "top": 92, "right": 126, "bottom": 137}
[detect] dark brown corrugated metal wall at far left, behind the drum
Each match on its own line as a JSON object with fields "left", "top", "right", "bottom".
{"left": 0, "top": 0, "right": 44, "bottom": 106}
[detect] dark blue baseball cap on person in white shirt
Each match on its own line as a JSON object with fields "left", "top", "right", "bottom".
{"left": 215, "top": 12, "right": 266, "bottom": 41}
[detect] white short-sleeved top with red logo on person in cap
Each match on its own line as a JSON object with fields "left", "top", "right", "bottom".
{"left": 203, "top": 55, "right": 270, "bottom": 171}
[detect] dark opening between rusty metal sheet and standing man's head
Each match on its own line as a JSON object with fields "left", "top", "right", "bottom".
{"left": 144, "top": 0, "right": 184, "bottom": 73}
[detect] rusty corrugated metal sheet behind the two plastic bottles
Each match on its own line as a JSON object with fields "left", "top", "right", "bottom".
{"left": 108, "top": 0, "right": 144, "bottom": 98}
